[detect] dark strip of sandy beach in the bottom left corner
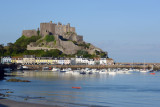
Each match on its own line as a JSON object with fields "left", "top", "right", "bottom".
{"left": 0, "top": 98, "right": 60, "bottom": 107}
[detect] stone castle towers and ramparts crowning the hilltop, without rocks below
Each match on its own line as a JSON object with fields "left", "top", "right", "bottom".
{"left": 22, "top": 21, "right": 83, "bottom": 42}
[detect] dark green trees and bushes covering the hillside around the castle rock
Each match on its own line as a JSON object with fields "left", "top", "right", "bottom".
{"left": 0, "top": 35, "right": 105, "bottom": 58}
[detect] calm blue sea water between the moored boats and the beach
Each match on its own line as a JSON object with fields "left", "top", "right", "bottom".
{"left": 0, "top": 72, "right": 160, "bottom": 107}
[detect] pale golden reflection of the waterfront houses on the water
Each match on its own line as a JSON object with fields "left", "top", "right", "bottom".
{"left": 10, "top": 71, "right": 112, "bottom": 80}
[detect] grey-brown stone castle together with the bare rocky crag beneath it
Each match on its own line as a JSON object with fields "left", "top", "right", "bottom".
{"left": 22, "top": 21, "right": 107, "bottom": 54}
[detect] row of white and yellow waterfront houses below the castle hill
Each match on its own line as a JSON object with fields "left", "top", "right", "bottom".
{"left": 5, "top": 55, "right": 114, "bottom": 65}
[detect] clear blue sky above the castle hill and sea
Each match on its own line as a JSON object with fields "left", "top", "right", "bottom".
{"left": 0, "top": 0, "right": 160, "bottom": 62}
